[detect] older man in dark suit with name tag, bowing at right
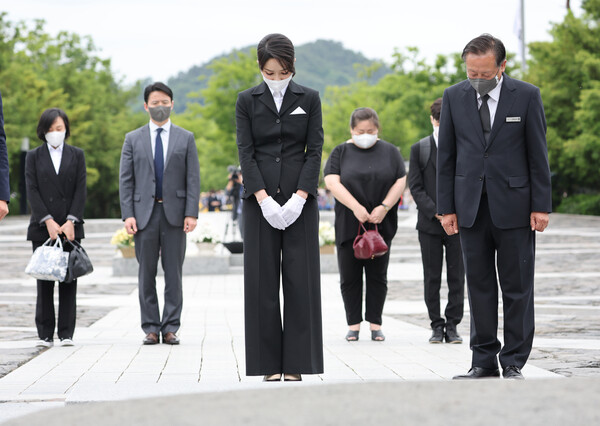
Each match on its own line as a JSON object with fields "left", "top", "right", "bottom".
{"left": 437, "top": 34, "right": 552, "bottom": 379}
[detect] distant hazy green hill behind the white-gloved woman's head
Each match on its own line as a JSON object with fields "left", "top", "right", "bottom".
{"left": 168, "top": 40, "right": 390, "bottom": 112}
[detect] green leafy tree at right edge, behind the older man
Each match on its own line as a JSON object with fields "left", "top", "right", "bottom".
{"left": 527, "top": 0, "right": 600, "bottom": 214}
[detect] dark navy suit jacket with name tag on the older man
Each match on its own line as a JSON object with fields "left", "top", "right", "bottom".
{"left": 437, "top": 74, "right": 552, "bottom": 229}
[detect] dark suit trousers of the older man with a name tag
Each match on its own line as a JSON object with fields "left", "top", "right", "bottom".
{"left": 460, "top": 195, "right": 535, "bottom": 368}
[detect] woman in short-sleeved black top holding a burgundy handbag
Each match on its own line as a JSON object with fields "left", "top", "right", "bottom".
{"left": 324, "top": 108, "right": 406, "bottom": 341}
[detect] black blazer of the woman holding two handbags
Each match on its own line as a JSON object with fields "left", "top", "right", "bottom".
{"left": 25, "top": 143, "right": 87, "bottom": 241}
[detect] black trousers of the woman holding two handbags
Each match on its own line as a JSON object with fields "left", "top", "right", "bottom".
{"left": 31, "top": 239, "right": 80, "bottom": 340}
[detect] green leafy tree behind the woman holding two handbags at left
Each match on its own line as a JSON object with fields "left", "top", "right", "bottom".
{"left": 0, "top": 14, "right": 147, "bottom": 217}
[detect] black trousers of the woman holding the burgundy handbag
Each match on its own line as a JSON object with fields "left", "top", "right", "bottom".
{"left": 337, "top": 241, "right": 391, "bottom": 325}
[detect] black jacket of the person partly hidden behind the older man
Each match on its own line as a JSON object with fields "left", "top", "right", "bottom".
{"left": 408, "top": 135, "right": 446, "bottom": 235}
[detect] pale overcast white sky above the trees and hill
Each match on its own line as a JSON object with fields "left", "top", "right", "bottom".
{"left": 0, "top": 0, "right": 581, "bottom": 82}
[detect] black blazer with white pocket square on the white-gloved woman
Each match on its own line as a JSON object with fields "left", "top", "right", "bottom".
{"left": 235, "top": 81, "right": 323, "bottom": 198}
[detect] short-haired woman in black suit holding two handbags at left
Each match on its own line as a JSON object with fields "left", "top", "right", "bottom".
{"left": 25, "top": 108, "right": 86, "bottom": 347}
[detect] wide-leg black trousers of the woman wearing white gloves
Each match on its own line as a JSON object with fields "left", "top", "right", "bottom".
{"left": 242, "top": 196, "right": 323, "bottom": 376}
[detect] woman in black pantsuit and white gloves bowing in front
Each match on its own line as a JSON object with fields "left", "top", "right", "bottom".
{"left": 236, "top": 34, "right": 323, "bottom": 381}
